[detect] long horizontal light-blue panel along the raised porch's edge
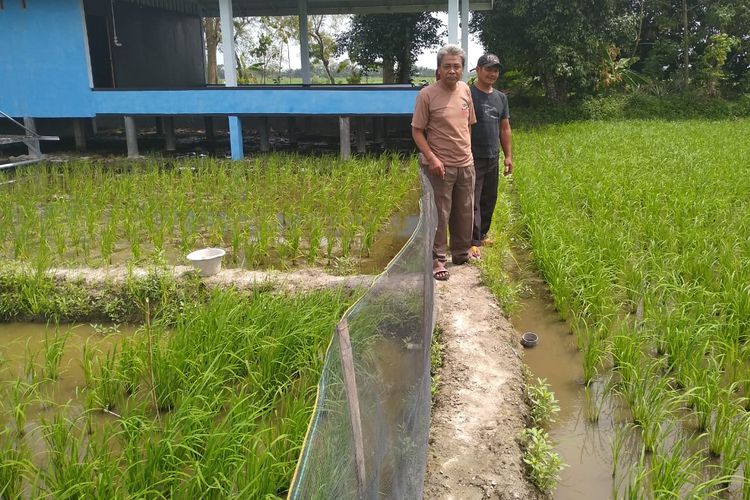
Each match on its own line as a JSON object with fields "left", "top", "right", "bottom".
{"left": 93, "top": 88, "right": 418, "bottom": 115}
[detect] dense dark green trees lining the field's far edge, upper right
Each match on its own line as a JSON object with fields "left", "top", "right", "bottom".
{"left": 471, "top": 0, "right": 750, "bottom": 102}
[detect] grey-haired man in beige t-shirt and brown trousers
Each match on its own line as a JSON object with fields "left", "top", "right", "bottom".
{"left": 411, "top": 45, "right": 477, "bottom": 281}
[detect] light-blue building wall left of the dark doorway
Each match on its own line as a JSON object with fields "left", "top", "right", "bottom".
{"left": 0, "top": 0, "right": 94, "bottom": 118}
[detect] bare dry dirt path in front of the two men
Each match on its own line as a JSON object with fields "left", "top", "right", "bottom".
{"left": 424, "top": 266, "right": 541, "bottom": 500}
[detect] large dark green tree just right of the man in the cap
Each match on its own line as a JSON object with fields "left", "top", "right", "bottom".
{"left": 471, "top": 0, "right": 637, "bottom": 101}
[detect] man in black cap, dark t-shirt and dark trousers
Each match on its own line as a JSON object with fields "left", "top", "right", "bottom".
{"left": 470, "top": 54, "right": 513, "bottom": 258}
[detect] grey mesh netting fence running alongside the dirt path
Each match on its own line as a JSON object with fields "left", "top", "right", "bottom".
{"left": 289, "top": 172, "right": 437, "bottom": 499}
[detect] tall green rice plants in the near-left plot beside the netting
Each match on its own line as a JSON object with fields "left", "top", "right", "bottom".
{"left": 0, "top": 274, "right": 351, "bottom": 498}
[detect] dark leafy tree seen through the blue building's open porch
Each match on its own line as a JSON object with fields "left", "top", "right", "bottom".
{"left": 338, "top": 12, "right": 442, "bottom": 83}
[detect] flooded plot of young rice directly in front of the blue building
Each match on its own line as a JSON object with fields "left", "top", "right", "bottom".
{"left": 0, "top": 155, "right": 419, "bottom": 269}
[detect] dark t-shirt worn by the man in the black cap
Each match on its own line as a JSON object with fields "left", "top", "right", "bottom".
{"left": 471, "top": 85, "right": 510, "bottom": 158}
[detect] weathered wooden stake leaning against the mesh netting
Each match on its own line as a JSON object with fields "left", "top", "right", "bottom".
{"left": 336, "top": 318, "right": 366, "bottom": 499}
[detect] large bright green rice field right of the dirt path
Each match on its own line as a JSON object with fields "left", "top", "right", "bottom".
{"left": 514, "top": 120, "right": 750, "bottom": 499}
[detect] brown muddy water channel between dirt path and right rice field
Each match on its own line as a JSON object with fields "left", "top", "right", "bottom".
{"left": 511, "top": 256, "right": 630, "bottom": 500}
